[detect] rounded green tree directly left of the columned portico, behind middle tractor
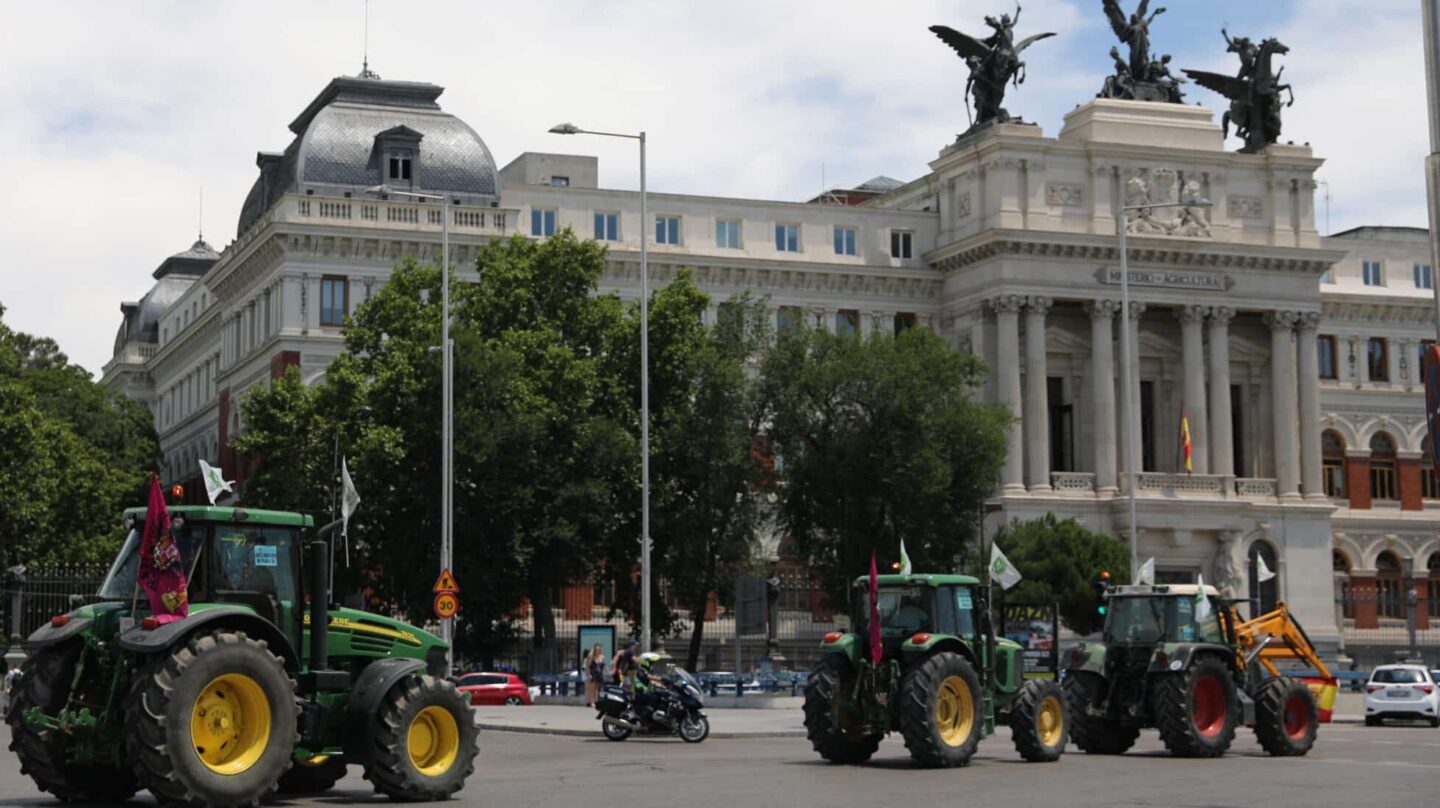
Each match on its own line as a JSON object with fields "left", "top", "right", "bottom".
{"left": 762, "top": 328, "right": 1009, "bottom": 599}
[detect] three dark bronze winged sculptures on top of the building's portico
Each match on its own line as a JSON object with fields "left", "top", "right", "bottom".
{"left": 930, "top": 0, "right": 1295, "bottom": 153}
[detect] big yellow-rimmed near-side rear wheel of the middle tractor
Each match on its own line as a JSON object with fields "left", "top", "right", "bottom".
{"left": 900, "top": 651, "right": 985, "bottom": 768}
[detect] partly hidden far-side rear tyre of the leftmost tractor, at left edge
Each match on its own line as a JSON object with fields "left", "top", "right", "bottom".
{"left": 6, "top": 642, "right": 135, "bottom": 802}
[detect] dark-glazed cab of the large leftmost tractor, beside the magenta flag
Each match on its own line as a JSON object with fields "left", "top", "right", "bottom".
{"left": 99, "top": 506, "right": 312, "bottom": 647}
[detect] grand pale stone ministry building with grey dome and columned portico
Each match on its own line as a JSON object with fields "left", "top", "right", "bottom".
{"left": 104, "top": 67, "right": 1440, "bottom": 654}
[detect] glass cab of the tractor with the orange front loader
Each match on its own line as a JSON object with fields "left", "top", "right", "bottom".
{"left": 1104, "top": 583, "right": 1225, "bottom": 647}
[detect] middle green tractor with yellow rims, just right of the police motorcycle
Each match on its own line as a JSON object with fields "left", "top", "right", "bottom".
{"left": 805, "top": 575, "right": 1068, "bottom": 768}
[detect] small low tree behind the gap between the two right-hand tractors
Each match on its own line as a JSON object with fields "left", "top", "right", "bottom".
{"left": 995, "top": 514, "right": 1130, "bottom": 634}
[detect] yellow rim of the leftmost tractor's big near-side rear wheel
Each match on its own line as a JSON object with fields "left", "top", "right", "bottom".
{"left": 190, "top": 674, "right": 271, "bottom": 775}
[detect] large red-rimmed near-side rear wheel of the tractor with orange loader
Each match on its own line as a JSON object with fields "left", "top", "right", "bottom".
{"left": 1155, "top": 657, "right": 1240, "bottom": 758}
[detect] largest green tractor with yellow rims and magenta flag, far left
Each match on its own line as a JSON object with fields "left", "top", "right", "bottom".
{"left": 6, "top": 507, "right": 478, "bottom": 808}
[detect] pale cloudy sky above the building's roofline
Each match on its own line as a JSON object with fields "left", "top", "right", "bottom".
{"left": 0, "top": 0, "right": 1428, "bottom": 376}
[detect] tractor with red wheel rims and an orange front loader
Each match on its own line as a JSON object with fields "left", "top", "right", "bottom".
{"left": 1061, "top": 583, "right": 1329, "bottom": 758}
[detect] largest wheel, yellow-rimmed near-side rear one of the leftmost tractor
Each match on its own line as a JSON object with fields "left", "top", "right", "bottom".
{"left": 125, "top": 629, "right": 300, "bottom": 808}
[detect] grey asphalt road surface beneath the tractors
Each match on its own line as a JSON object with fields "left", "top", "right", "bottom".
{"left": 0, "top": 726, "right": 1440, "bottom": 808}
